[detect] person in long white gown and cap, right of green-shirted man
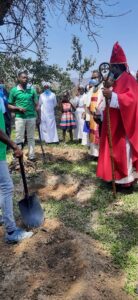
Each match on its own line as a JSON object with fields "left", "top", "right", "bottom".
{"left": 39, "top": 81, "right": 59, "bottom": 144}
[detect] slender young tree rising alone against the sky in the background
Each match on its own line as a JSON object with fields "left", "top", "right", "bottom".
{"left": 67, "top": 36, "right": 95, "bottom": 84}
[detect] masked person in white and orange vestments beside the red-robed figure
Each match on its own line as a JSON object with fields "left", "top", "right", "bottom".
{"left": 86, "top": 70, "right": 105, "bottom": 160}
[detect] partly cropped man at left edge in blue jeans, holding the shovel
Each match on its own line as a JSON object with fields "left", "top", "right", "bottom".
{"left": 0, "top": 105, "right": 33, "bottom": 243}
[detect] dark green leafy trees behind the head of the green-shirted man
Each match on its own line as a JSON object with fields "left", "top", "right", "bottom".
{"left": 0, "top": 54, "right": 73, "bottom": 94}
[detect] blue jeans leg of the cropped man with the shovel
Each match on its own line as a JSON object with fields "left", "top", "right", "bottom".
{"left": 0, "top": 160, "right": 16, "bottom": 232}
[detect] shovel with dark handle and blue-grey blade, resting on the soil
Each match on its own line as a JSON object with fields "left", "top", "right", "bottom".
{"left": 19, "top": 158, "right": 44, "bottom": 227}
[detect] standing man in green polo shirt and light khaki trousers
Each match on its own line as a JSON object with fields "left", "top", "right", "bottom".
{"left": 8, "top": 72, "right": 39, "bottom": 161}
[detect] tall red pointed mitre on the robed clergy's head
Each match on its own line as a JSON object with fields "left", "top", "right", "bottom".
{"left": 110, "top": 42, "right": 127, "bottom": 66}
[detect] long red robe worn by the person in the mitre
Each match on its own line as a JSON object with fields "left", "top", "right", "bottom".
{"left": 97, "top": 72, "right": 138, "bottom": 181}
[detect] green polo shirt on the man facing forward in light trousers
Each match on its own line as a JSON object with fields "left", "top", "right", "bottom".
{"left": 9, "top": 85, "right": 38, "bottom": 119}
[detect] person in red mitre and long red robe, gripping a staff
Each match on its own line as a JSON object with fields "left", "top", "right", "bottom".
{"left": 97, "top": 42, "right": 138, "bottom": 192}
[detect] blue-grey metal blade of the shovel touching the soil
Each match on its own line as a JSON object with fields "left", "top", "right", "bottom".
{"left": 19, "top": 194, "right": 44, "bottom": 228}
